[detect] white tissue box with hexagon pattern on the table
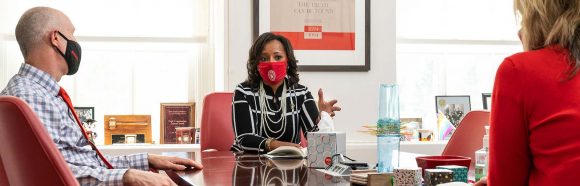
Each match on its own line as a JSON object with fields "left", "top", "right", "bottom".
{"left": 307, "top": 132, "right": 346, "bottom": 168}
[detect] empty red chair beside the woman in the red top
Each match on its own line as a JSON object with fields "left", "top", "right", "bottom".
{"left": 441, "top": 111, "right": 489, "bottom": 167}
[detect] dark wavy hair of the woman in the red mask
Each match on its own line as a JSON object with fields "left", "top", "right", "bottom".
{"left": 245, "top": 32, "right": 300, "bottom": 88}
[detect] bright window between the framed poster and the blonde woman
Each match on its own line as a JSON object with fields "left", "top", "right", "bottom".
{"left": 396, "top": 0, "right": 522, "bottom": 129}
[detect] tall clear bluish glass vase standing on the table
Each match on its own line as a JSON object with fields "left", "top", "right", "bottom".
{"left": 377, "top": 84, "right": 401, "bottom": 173}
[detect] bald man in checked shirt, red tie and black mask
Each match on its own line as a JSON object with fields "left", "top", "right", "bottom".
{"left": 0, "top": 7, "right": 202, "bottom": 185}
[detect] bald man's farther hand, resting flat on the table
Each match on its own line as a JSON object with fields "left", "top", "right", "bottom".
{"left": 147, "top": 154, "right": 203, "bottom": 170}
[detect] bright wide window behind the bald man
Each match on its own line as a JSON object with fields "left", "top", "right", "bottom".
{"left": 0, "top": 0, "right": 223, "bottom": 144}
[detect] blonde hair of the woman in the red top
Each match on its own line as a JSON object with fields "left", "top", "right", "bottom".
{"left": 514, "top": 0, "right": 580, "bottom": 78}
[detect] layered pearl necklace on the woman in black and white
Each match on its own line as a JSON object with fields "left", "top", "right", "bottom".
{"left": 258, "top": 82, "right": 286, "bottom": 137}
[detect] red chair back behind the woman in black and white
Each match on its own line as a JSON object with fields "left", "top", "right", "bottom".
{"left": 200, "top": 92, "right": 234, "bottom": 151}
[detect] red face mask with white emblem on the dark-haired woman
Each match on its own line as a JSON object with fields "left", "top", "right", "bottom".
{"left": 258, "top": 61, "right": 288, "bottom": 85}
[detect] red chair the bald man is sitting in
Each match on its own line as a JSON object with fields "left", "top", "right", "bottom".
{"left": 0, "top": 96, "right": 79, "bottom": 185}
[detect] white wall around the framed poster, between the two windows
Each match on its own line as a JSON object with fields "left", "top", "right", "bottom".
{"left": 226, "top": 0, "right": 396, "bottom": 163}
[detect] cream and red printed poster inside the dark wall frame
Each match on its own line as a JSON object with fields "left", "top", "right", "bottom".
{"left": 270, "top": 0, "right": 355, "bottom": 50}
